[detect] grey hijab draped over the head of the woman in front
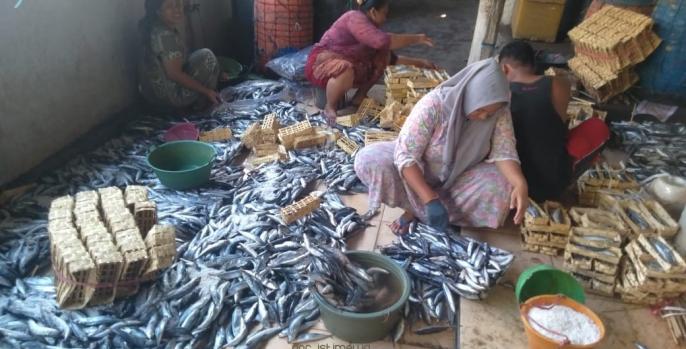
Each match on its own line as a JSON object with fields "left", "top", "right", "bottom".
{"left": 436, "top": 58, "right": 510, "bottom": 189}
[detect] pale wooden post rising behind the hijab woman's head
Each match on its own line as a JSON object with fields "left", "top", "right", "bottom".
{"left": 468, "top": 0, "right": 505, "bottom": 64}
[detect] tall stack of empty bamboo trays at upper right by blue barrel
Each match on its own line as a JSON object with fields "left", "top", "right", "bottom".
{"left": 568, "top": 6, "right": 661, "bottom": 101}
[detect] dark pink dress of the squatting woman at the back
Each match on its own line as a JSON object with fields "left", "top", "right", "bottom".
{"left": 305, "top": 11, "right": 391, "bottom": 88}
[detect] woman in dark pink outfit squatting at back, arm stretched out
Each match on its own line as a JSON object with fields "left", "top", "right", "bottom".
{"left": 305, "top": 0, "right": 434, "bottom": 124}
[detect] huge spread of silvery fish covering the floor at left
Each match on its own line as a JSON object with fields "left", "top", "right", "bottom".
{"left": 0, "top": 81, "right": 384, "bottom": 348}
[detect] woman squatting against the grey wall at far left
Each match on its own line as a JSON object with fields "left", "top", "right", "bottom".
{"left": 138, "top": 0, "right": 220, "bottom": 108}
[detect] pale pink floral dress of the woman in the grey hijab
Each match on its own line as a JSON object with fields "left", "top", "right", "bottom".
{"left": 355, "top": 93, "right": 519, "bottom": 228}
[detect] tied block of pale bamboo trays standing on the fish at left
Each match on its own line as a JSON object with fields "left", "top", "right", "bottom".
{"left": 48, "top": 186, "right": 176, "bottom": 309}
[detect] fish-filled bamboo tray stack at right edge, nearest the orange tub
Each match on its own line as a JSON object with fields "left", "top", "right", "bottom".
{"left": 618, "top": 235, "right": 686, "bottom": 305}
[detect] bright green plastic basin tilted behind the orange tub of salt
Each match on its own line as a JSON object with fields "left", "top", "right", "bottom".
{"left": 515, "top": 264, "right": 586, "bottom": 304}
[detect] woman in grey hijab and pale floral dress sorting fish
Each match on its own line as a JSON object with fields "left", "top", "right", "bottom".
{"left": 355, "top": 58, "right": 528, "bottom": 234}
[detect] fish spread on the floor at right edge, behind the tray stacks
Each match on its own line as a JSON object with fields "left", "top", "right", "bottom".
{"left": 611, "top": 121, "right": 686, "bottom": 181}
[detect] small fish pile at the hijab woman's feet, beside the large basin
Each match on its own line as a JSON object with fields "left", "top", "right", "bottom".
{"left": 382, "top": 223, "right": 514, "bottom": 328}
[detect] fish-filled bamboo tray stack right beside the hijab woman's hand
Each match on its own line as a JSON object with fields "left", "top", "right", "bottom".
{"left": 521, "top": 200, "right": 572, "bottom": 256}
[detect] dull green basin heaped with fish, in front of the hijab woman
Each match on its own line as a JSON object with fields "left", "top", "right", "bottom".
{"left": 313, "top": 251, "right": 410, "bottom": 343}
